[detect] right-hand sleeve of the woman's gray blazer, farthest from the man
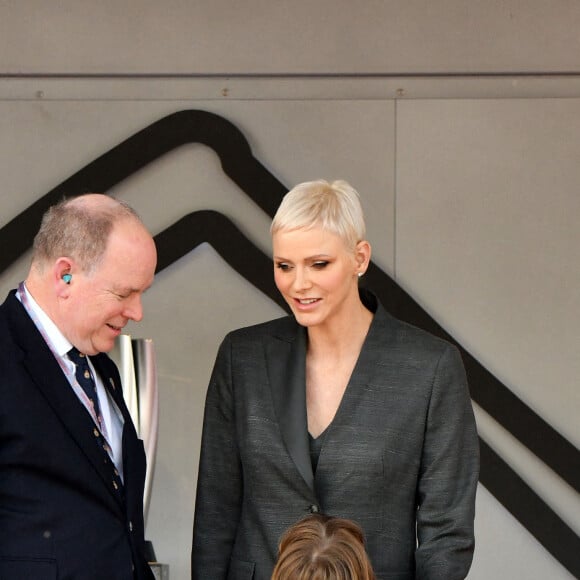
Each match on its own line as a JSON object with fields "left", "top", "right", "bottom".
{"left": 415, "top": 345, "right": 479, "bottom": 580}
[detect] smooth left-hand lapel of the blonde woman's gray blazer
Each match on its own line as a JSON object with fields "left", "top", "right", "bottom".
{"left": 265, "top": 325, "right": 314, "bottom": 490}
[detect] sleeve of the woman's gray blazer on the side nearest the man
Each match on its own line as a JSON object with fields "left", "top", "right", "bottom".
{"left": 191, "top": 336, "right": 243, "bottom": 580}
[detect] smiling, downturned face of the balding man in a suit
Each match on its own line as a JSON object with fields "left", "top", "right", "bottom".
{"left": 60, "top": 219, "right": 157, "bottom": 354}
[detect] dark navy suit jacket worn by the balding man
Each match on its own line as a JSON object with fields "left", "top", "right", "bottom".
{"left": 0, "top": 291, "right": 153, "bottom": 580}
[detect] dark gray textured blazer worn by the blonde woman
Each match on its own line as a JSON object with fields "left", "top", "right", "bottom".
{"left": 192, "top": 295, "right": 479, "bottom": 580}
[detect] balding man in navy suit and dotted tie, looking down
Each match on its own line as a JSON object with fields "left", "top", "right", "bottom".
{"left": 0, "top": 194, "right": 157, "bottom": 580}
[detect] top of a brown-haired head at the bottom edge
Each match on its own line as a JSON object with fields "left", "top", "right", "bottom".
{"left": 272, "top": 514, "right": 375, "bottom": 580}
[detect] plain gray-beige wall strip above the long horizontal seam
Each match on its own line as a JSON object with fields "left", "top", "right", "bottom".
{"left": 0, "top": 0, "right": 580, "bottom": 75}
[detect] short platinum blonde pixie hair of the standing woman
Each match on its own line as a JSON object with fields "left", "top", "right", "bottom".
{"left": 270, "top": 179, "right": 366, "bottom": 250}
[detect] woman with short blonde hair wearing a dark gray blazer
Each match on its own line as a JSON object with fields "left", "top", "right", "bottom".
{"left": 192, "top": 181, "right": 479, "bottom": 580}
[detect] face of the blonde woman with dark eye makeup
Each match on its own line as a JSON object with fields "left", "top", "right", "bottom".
{"left": 272, "top": 227, "right": 368, "bottom": 327}
